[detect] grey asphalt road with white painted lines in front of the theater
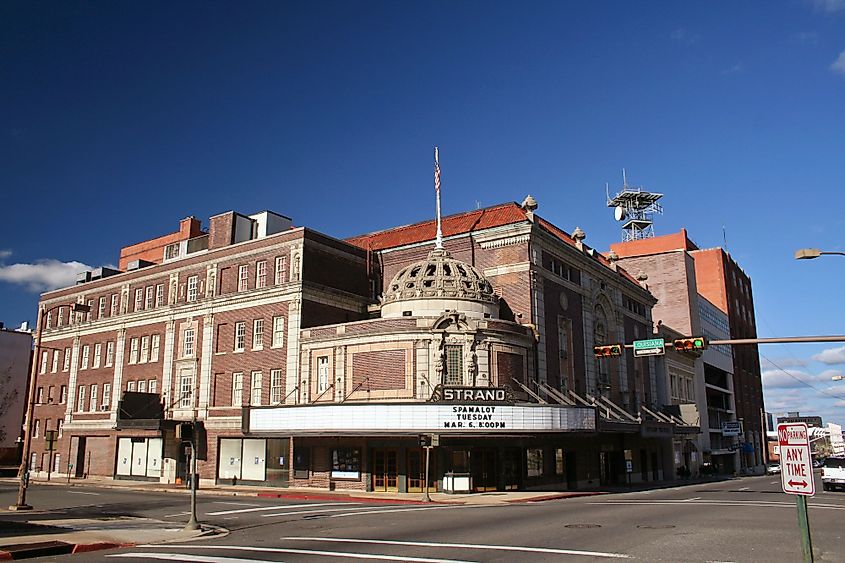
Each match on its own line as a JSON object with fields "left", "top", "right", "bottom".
{"left": 0, "top": 476, "right": 845, "bottom": 563}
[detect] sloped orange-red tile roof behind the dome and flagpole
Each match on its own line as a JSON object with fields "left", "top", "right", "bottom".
{"left": 346, "top": 202, "right": 528, "bottom": 250}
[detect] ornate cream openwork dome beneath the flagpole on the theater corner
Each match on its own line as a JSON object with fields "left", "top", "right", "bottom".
{"left": 382, "top": 249, "right": 499, "bottom": 318}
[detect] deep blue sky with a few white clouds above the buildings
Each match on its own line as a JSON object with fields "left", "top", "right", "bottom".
{"left": 0, "top": 0, "right": 845, "bottom": 423}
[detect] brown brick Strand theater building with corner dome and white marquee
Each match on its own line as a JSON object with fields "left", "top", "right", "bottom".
{"left": 32, "top": 197, "right": 700, "bottom": 491}
